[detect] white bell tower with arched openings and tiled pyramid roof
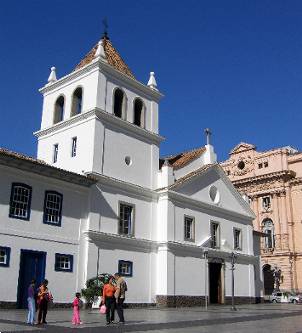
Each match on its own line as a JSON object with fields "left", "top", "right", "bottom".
{"left": 34, "top": 32, "right": 163, "bottom": 189}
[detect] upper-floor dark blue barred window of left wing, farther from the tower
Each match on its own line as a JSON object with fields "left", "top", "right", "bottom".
{"left": 9, "top": 183, "right": 32, "bottom": 220}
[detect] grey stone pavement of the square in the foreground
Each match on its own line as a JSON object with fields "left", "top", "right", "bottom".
{"left": 0, "top": 304, "right": 302, "bottom": 333}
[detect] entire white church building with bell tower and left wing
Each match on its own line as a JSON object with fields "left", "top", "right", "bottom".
{"left": 0, "top": 35, "right": 262, "bottom": 307}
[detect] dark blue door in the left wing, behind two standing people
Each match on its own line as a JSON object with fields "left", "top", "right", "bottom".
{"left": 17, "top": 250, "right": 46, "bottom": 309}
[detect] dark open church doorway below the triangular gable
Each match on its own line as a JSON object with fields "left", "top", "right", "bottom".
{"left": 209, "top": 262, "right": 223, "bottom": 304}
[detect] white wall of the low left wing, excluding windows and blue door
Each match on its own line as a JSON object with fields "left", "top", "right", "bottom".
{"left": 0, "top": 166, "right": 88, "bottom": 303}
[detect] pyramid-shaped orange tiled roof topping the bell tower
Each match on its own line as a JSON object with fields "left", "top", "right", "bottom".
{"left": 75, "top": 38, "right": 135, "bottom": 79}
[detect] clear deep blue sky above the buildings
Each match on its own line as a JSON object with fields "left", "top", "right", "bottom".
{"left": 0, "top": 0, "right": 302, "bottom": 160}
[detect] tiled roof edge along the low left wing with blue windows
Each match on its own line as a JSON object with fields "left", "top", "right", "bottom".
{"left": 0, "top": 147, "right": 97, "bottom": 186}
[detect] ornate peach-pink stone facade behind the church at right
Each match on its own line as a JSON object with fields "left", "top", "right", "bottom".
{"left": 221, "top": 143, "right": 302, "bottom": 294}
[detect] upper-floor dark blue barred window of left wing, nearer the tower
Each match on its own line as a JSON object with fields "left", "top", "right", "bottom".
{"left": 43, "top": 191, "right": 63, "bottom": 226}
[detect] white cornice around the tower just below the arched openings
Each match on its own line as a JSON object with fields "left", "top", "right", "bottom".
{"left": 33, "top": 108, "right": 165, "bottom": 144}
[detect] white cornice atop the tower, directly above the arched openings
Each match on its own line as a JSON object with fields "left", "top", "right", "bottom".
{"left": 39, "top": 59, "right": 163, "bottom": 101}
